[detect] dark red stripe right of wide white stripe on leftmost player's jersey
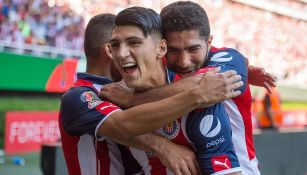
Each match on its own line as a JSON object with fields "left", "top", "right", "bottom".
{"left": 96, "top": 140, "right": 110, "bottom": 175}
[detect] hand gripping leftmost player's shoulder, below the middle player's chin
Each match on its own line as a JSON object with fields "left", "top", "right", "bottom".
{"left": 99, "top": 82, "right": 133, "bottom": 108}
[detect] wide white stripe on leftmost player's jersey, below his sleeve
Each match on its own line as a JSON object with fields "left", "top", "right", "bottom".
{"left": 76, "top": 134, "right": 96, "bottom": 175}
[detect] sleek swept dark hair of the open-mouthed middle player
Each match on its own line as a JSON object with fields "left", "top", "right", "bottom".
{"left": 115, "top": 6, "right": 162, "bottom": 37}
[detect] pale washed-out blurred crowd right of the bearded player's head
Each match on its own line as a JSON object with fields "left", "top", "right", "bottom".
{"left": 205, "top": 1, "right": 307, "bottom": 87}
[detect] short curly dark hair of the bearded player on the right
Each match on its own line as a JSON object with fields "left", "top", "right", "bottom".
{"left": 160, "top": 1, "right": 210, "bottom": 38}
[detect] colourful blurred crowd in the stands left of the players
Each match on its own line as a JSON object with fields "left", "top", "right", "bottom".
{"left": 0, "top": 0, "right": 84, "bottom": 50}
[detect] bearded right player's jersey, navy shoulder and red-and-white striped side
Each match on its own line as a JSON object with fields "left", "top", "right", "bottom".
{"left": 205, "top": 47, "right": 260, "bottom": 175}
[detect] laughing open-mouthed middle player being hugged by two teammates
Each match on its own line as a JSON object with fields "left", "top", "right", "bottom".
{"left": 110, "top": 7, "right": 247, "bottom": 175}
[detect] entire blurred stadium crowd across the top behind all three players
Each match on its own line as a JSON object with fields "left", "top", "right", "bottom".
{"left": 0, "top": 0, "right": 307, "bottom": 87}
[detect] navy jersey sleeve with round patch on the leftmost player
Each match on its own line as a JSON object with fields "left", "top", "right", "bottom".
{"left": 60, "top": 87, "right": 121, "bottom": 140}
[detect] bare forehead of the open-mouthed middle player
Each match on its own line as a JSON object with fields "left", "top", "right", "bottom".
{"left": 111, "top": 26, "right": 145, "bottom": 40}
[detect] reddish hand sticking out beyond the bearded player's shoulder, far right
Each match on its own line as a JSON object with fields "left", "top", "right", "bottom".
{"left": 248, "top": 66, "right": 276, "bottom": 94}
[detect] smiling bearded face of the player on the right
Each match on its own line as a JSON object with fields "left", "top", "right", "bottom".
{"left": 166, "top": 30, "right": 212, "bottom": 75}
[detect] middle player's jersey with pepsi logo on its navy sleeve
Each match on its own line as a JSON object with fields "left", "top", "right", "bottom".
{"left": 130, "top": 69, "right": 240, "bottom": 175}
